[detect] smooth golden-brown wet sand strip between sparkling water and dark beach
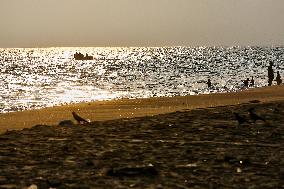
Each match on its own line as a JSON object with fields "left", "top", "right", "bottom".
{"left": 0, "top": 85, "right": 284, "bottom": 134}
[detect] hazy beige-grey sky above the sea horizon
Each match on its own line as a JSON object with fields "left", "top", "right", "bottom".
{"left": 0, "top": 0, "right": 284, "bottom": 47}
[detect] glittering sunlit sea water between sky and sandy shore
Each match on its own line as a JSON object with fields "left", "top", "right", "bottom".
{"left": 0, "top": 47, "right": 284, "bottom": 112}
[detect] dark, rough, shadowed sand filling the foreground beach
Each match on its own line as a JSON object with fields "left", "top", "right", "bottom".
{"left": 0, "top": 100, "right": 284, "bottom": 189}
